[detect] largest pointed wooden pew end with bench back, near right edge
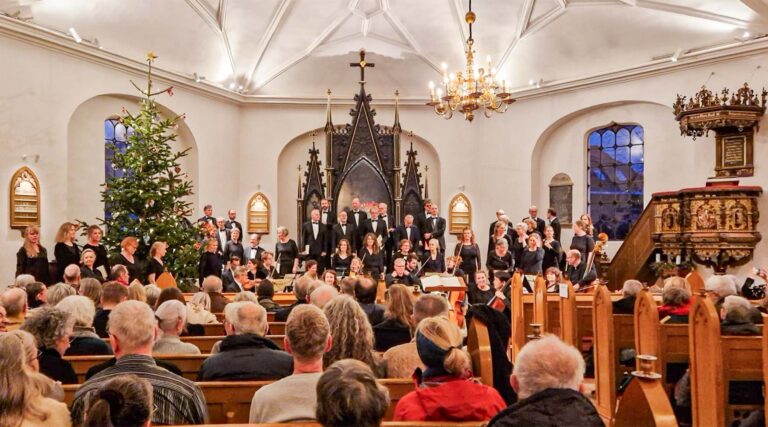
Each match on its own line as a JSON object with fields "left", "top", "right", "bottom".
{"left": 689, "top": 295, "right": 765, "bottom": 426}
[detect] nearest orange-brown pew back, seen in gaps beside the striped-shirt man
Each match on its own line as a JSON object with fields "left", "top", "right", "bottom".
{"left": 64, "top": 378, "right": 422, "bottom": 426}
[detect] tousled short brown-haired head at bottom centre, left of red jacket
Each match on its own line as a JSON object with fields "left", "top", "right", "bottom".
{"left": 316, "top": 359, "right": 389, "bottom": 427}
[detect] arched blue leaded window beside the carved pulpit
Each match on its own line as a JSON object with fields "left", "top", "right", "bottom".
{"left": 587, "top": 123, "right": 645, "bottom": 240}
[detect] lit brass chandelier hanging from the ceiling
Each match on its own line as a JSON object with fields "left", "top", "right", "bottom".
{"left": 427, "top": 0, "right": 515, "bottom": 122}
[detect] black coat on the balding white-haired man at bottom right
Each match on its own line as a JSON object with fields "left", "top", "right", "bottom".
{"left": 489, "top": 388, "right": 604, "bottom": 427}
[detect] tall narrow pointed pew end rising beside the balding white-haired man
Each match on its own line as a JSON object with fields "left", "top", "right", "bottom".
{"left": 592, "top": 285, "right": 634, "bottom": 426}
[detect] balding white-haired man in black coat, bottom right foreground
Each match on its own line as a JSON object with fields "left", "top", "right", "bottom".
{"left": 489, "top": 335, "right": 604, "bottom": 427}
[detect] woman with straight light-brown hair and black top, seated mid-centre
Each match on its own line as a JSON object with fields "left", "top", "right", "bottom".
{"left": 373, "top": 285, "right": 415, "bottom": 351}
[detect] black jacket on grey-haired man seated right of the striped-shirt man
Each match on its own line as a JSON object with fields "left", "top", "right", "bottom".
{"left": 197, "top": 334, "right": 293, "bottom": 381}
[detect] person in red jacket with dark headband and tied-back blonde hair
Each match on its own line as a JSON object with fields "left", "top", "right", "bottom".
{"left": 394, "top": 317, "right": 506, "bottom": 422}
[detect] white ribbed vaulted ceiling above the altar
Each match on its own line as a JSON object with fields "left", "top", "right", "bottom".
{"left": 0, "top": 0, "right": 768, "bottom": 97}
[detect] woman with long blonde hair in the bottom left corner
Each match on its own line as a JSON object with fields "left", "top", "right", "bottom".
{"left": 0, "top": 334, "right": 71, "bottom": 427}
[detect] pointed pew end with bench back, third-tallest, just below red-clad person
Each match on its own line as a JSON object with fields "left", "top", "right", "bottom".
{"left": 635, "top": 289, "right": 689, "bottom": 390}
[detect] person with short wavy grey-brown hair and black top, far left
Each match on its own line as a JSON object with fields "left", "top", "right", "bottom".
{"left": 21, "top": 306, "right": 77, "bottom": 384}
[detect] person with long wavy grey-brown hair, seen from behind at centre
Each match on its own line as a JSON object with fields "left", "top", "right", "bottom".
{"left": 323, "top": 295, "right": 384, "bottom": 377}
